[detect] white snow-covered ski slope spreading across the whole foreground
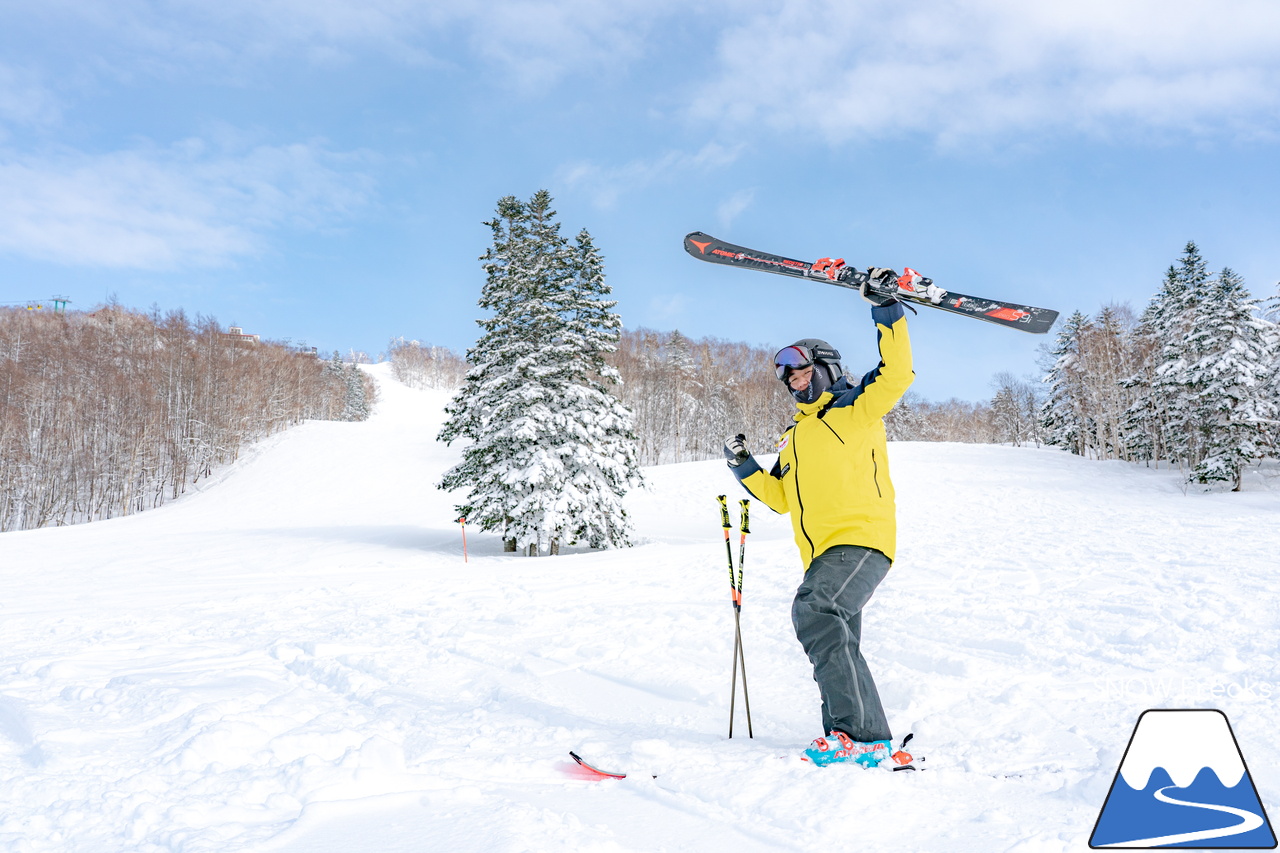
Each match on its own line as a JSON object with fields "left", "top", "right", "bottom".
{"left": 0, "top": 365, "right": 1280, "bottom": 853}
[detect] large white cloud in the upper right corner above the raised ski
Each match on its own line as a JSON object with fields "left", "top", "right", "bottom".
{"left": 691, "top": 0, "right": 1280, "bottom": 142}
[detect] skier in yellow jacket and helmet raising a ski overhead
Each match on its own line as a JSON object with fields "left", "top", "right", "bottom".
{"left": 724, "top": 268, "right": 915, "bottom": 767}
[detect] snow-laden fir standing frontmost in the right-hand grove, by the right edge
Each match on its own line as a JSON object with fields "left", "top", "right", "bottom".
{"left": 1183, "top": 268, "right": 1276, "bottom": 489}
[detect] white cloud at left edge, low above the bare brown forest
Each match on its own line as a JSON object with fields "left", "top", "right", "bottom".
{"left": 0, "top": 140, "right": 371, "bottom": 269}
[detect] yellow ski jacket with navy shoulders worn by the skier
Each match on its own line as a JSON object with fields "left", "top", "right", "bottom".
{"left": 731, "top": 302, "right": 915, "bottom": 571}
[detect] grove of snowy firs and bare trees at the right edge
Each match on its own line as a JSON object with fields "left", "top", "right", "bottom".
{"left": 1039, "top": 242, "right": 1280, "bottom": 479}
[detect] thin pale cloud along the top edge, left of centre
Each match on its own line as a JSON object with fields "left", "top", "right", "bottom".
{"left": 17, "top": 0, "right": 691, "bottom": 90}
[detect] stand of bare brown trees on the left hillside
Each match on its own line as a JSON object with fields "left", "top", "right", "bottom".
{"left": 0, "top": 305, "right": 372, "bottom": 530}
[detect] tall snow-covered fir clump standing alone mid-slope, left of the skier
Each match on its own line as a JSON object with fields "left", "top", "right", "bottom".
{"left": 439, "top": 191, "right": 639, "bottom": 553}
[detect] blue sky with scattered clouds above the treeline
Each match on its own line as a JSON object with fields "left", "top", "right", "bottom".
{"left": 0, "top": 0, "right": 1280, "bottom": 400}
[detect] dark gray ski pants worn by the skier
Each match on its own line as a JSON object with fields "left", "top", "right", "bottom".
{"left": 791, "top": 546, "right": 891, "bottom": 743}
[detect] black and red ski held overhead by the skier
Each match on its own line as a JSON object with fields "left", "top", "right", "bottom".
{"left": 685, "top": 231, "right": 1057, "bottom": 334}
